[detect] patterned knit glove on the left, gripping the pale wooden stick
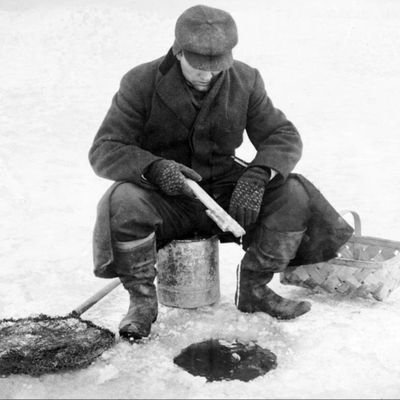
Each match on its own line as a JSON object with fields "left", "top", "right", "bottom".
{"left": 144, "top": 160, "right": 202, "bottom": 197}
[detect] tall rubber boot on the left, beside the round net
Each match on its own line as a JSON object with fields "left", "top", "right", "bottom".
{"left": 114, "top": 233, "right": 158, "bottom": 342}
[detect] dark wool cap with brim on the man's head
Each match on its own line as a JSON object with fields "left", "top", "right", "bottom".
{"left": 172, "top": 5, "right": 238, "bottom": 71}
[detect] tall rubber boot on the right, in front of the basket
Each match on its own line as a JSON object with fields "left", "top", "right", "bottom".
{"left": 235, "top": 231, "right": 311, "bottom": 319}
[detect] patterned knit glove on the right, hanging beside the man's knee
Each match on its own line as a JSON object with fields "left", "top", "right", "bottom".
{"left": 229, "top": 167, "right": 271, "bottom": 228}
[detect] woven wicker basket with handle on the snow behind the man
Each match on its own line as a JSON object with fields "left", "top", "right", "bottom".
{"left": 280, "top": 210, "right": 400, "bottom": 301}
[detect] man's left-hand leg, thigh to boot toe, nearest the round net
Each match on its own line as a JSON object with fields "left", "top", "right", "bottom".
{"left": 110, "top": 183, "right": 203, "bottom": 340}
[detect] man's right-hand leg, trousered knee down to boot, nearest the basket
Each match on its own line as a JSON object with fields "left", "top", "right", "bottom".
{"left": 235, "top": 178, "right": 311, "bottom": 319}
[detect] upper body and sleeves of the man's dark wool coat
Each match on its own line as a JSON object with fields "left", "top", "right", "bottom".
{"left": 89, "top": 52, "right": 302, "bottom": 185}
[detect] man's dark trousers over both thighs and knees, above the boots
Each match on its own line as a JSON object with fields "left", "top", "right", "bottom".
{"left": 110, "top": 177, "right": 310, "bottom": 253}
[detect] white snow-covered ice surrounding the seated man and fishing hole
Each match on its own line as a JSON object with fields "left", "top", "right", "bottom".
{"left": 0, "top": 0, "right": 400, "bottom": 399}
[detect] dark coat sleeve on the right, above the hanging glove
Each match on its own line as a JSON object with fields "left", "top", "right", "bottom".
{"left": 246, "top": 70, "right": 302, "bottom": 180}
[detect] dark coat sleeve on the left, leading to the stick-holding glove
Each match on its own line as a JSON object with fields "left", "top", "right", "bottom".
{"left": 89, "top": 69, "right": 160, "bottom": 184}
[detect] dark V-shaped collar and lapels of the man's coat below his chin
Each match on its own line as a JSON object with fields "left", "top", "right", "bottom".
{"left": 156, "top": 52, "right": 225, "bottom": 130}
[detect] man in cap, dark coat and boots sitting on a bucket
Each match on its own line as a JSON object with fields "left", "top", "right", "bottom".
{"left": 89, "top": 5, "right": 352, "bottom": 340}
